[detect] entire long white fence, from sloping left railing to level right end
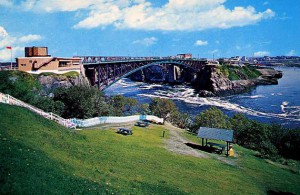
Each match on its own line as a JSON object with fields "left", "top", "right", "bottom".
{"left": 0, "top": 92, "right": 163, "bottom": 128}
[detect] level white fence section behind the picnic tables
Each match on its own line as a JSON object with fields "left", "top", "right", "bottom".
{"left": 71, "top": 115, "right": 163, "bottom": 127}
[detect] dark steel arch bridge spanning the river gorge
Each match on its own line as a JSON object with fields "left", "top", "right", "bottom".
{"left": 78, "top": 56, "right": 207, "bottom": 90}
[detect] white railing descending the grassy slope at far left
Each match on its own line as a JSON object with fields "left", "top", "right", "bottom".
{"left": 0, "top": 92, "right": 76, "bottom": 128}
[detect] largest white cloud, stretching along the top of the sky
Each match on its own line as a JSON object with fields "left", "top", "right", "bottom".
{"left": 11, "top": 0, "right": 275, "bottom": 31}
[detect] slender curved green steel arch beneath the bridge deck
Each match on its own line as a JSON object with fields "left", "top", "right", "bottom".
{"left": 102, "top": 60, "right": 198, "bottom": 90}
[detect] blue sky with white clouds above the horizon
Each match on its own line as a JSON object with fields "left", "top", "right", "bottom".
{"left": 0, "top": 0, "right": 300, "bottom": 62}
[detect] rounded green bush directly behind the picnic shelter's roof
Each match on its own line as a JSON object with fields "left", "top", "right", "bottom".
{"left": 191, "top": 107, "right": 231, "bottom": 133}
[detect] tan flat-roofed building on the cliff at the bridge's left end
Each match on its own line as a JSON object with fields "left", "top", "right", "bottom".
{"left": 16, "top": 47, "right": 82, "bottom": 74}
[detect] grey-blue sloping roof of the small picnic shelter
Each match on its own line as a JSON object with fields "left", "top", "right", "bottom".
{"left": 198, "top": 127, "right": 233, "bottom": 142}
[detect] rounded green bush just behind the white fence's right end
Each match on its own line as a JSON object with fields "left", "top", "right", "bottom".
{"left": 149, "top": 98, "right": 177, "bottom": 123}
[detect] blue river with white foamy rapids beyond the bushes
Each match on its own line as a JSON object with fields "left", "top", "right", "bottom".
{"left": 105, "top": 67, "right": 300, "bottom": 127}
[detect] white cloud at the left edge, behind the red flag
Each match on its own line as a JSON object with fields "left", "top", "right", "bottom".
{"left": 0, "top": 26, "right": 42, "bottom": 61}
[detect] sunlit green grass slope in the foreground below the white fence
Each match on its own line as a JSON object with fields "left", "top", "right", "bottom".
{"left": 0, "top": 104, "right": 300, "bottom": 194}
